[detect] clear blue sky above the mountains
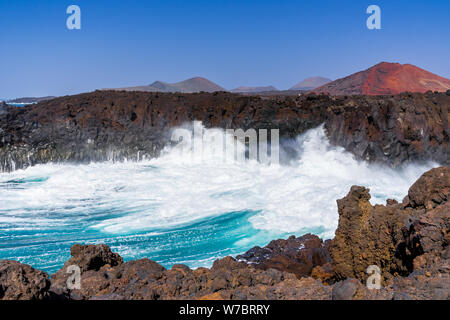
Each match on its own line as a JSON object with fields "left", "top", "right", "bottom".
{"left": 0, "top": 0, "right": 450, "bottom": 98}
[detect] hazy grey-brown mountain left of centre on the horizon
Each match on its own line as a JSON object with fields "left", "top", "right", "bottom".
{"left": 104, "top": 77, "right": 227, "bottom": 93}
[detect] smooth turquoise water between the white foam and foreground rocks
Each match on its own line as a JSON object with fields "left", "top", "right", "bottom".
{"left": 0, "top": 188, "right": 284, "bottom": 273}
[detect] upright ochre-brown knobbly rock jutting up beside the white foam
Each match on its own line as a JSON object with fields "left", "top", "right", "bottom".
{"left": 331, "top": 186, "right": 406, "bottom": 279}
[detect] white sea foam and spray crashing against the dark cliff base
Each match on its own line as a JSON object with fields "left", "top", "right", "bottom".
{"left": 0, "top": 127, "right": 437, "bottom": 237}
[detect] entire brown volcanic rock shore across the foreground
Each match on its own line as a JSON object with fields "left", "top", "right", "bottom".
{"left": 0, "top": 167, "right": 450, "bottom": 300}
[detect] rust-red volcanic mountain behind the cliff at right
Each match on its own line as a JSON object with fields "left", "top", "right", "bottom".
{"left": 314, "top": 62, "right": 450, "bottom": 96}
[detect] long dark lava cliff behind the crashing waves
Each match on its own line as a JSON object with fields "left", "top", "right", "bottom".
{"left": 0, "top": 91, "right": 450, "bottom": 171}
